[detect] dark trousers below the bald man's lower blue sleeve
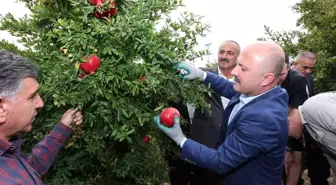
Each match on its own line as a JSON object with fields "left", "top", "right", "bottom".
{"left": 170, "top": 155, "right": 222, "bottom": 185}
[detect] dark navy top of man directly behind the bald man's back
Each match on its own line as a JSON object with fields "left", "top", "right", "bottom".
{"left": 281, "top": 69, "right": 308, "bottom": 108}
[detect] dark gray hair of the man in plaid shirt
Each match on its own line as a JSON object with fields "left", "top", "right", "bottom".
{"left": 0, "top": 50, "right": 38, "bottom": 98}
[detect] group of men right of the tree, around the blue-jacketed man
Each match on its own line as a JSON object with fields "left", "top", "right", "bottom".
{"left": 156, "top": 40, "right": 336, "bottom": 185}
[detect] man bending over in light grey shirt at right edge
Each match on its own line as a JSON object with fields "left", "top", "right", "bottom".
{"left": 288, "top": 91, "right": 336, "bottom": 185}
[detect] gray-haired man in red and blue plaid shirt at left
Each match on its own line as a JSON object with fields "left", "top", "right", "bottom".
{"left": 0, "top": 50, "right": 83, "bottom": 185}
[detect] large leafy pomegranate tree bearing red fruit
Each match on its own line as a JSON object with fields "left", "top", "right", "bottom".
{"left": 0, "top": 0, "right": 213, "bottom": 185}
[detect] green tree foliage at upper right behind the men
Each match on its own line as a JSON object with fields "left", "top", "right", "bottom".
{"left": 261, "top": 0, "right": 336, "bottom": 93}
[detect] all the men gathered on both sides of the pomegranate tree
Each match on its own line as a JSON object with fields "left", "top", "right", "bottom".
{"left": 0, "top": 40, "right": 336, "bottom": 185}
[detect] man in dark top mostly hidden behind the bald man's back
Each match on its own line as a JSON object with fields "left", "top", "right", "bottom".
{"left": 279, "top": 55, "right": 308, "bottom": 185}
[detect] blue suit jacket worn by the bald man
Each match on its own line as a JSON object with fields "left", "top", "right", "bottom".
{"left": 182, "top": 72, "right": 288, "bottom": 185}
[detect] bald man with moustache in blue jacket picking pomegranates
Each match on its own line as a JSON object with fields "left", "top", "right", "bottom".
{"left": 154, "top": 42, "right": 288, "bottom": 185}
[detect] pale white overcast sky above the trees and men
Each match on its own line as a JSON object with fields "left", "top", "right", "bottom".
{"left": 0, "top": 0, "right": 299, "bottom": 66}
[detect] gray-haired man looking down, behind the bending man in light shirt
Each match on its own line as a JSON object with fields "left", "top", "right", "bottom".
{"left": 292, "top": 51, "right": 330, "bottom": 185}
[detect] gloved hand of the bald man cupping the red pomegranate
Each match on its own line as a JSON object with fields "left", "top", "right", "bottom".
{"left": 154, "top": 116, "right": 187, "bottom": 147}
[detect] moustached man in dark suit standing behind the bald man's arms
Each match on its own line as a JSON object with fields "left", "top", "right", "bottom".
{"left": 170, "top": 40, "right": 240, "bottom": 185}
